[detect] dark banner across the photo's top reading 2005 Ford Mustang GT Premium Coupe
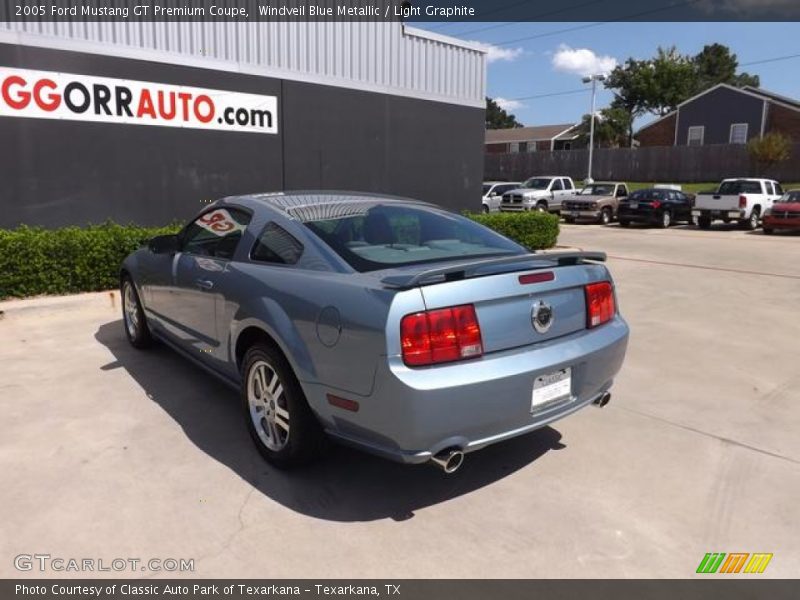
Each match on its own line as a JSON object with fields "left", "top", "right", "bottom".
{"left": 0, "top": 0, "right": 800, "bottom": 23}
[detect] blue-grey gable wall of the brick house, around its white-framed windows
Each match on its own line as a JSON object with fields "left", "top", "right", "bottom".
{"left": 677, "top": 87, "right": 764, "bottom": 146}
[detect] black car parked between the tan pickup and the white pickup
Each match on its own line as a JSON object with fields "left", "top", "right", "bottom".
{"left": 617, "top": 188, "right": 694, "bottom": 229}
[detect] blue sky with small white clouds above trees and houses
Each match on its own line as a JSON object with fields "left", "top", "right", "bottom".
{"left": 412, "top": 22, "right": 800, "bottom": 127}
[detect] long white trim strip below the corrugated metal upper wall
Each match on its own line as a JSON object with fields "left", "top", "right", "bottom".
{"left": 0, "top": 30, "right": 486, "bottom": 108}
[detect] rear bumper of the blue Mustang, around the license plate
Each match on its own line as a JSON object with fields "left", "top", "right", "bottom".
{"left": 316, "top": 316, "right": 628, "bottom": 463}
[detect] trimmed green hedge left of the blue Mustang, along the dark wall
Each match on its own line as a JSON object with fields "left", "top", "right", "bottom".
{"left": 0, "top": 223, "right": 178, "bottom": 299}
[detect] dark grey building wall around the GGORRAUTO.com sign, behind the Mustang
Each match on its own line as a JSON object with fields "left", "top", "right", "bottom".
{"left": 0, "top": 44, "right": 484, "bottom": 227}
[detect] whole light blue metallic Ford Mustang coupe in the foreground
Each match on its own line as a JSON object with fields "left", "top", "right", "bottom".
{"left": 121, "top": 192, "right": 628, "bottom": 472}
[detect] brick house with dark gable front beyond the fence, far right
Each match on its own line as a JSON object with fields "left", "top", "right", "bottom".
{"left": 634, "top": 83, "right": 800, "bottom": 146}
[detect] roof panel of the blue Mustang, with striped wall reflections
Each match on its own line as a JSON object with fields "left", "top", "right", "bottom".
{"left": 219, "top": 190, "right": 443, "bottom": 221}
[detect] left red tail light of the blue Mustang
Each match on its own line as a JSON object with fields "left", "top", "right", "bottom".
{"left": 400, "top": 304, "right": 483, "bottom": 367}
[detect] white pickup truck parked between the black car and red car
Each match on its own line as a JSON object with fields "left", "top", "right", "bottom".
{"left": 692, "top": 177, "right": 783, "bottom": 229}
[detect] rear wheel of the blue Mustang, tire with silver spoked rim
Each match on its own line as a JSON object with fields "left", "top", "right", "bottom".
{"left": 241, "top": 343, "right": 325, "bottom": 469}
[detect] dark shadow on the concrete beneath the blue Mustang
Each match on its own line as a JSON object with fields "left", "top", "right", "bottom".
{"left": 95, "top": 320, "right": 564, "bottom": 521}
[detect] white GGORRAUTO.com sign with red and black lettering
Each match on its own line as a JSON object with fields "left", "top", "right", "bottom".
{"left": 0, "top": 67, "right": 278, "bottom": 133}
